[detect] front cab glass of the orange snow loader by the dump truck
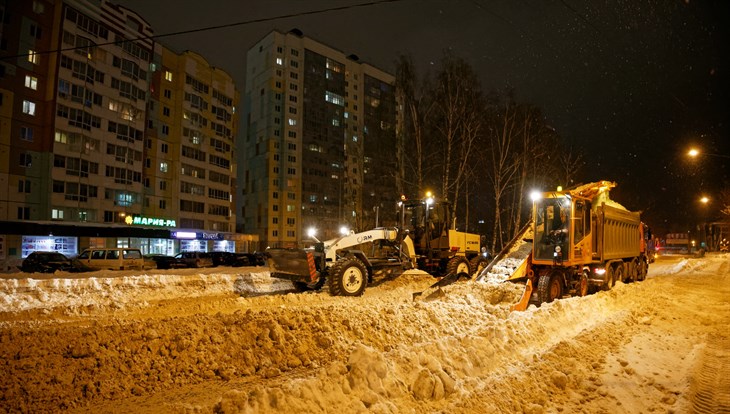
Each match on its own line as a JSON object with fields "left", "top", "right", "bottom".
{"left": 534, "top": 196, "right": 571, "bottom": 260}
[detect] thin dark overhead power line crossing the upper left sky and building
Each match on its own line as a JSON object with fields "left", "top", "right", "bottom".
{"left": 0, "top": 0, "right": 405, "bottom": 60}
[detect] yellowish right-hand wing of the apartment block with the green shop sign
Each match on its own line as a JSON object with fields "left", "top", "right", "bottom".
{"left": 144, "top": 44, "right": 239, "bottom": 251}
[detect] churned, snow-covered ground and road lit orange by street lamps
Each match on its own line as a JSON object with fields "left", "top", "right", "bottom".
{"left": 0, "top": 255, "right": 730, "bottom": 413}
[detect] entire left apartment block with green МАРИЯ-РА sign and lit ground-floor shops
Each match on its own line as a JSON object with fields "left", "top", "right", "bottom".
{"left": 0, "top": 0, "right": 243, "bottom": 266}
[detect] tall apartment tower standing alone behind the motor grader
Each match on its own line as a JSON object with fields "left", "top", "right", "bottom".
{"left": 238, "top": 30, "right": 399, "bottom": 247}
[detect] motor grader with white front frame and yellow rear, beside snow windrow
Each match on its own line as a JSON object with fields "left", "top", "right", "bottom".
{"left": 266, "top": 197, "right": 487, "bottom": 296}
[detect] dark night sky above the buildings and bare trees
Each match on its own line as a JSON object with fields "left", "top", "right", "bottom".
{"left": 117, "top": 0, "right": 730, "bottom": 234}
